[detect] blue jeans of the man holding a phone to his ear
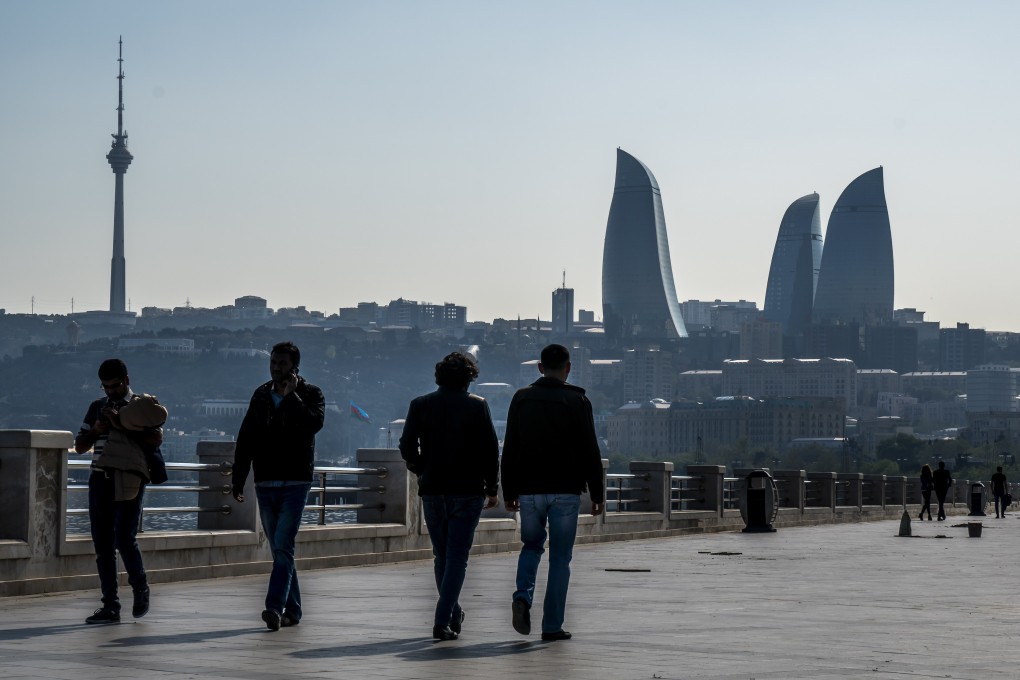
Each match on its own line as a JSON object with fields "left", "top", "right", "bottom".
{"left": 255, "top": 482, "right": 311, "bottom": 621}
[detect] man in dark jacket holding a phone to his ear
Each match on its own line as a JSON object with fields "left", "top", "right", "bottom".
{"left": 233, "top": 343, "right": 325, "bottom": 630}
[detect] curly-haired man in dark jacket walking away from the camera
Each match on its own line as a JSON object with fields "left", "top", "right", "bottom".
{"left": 400, "top": 352, "right": 500, "bottom": 640}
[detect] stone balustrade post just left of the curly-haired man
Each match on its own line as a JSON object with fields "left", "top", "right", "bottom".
{"left": 357, "top": 449, "right": 408, "bottom": 527}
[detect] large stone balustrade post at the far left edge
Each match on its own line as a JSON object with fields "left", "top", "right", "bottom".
{"left": 0, "top": 430, "right": 74, "bottom": 566}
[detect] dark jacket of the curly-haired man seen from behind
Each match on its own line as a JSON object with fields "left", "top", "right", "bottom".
{"left": 400, "top": 387, "right": 500, "bottom": 495}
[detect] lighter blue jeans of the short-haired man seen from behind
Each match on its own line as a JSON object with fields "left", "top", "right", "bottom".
{"left": 513, "top": 493, "right": 580, "bottom": 633}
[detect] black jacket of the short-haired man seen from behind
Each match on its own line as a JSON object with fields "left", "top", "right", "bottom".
{"left": 502, "top": 377, "right": 606, "bottom": 503}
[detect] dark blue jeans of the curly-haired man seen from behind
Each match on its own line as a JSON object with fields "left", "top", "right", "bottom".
{"left": 421, "top": 495, "right": 485, "bottom": 626}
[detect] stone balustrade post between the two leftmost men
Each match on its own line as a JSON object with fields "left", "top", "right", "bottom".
{"left": 195, "top": 441, "right": 260, "bottom": 531}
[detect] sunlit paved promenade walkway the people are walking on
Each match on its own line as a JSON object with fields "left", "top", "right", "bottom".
{"left": 0, "top": 515, "right": 1020, "bottom": 680}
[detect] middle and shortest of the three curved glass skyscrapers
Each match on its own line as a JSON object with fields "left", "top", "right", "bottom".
{"left": 765, "top": 194, "right": 822, "bottom": 335}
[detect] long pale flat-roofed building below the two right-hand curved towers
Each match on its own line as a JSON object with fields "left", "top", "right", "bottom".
{"left": 722, "top": 359, "right": 857, "bottom": 408}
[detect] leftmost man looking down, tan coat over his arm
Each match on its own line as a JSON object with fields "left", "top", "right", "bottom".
{"left": 74, "top": 359, "right": 163, "bottom": 624}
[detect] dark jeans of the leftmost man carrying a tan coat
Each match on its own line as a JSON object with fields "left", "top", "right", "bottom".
{"left": 89, "top": 470, "right": 148, "bottom": 612}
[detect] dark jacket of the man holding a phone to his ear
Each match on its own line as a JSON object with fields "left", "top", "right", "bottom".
{"left": 233, "top": 377, "right": 325, "bottom": 488}
